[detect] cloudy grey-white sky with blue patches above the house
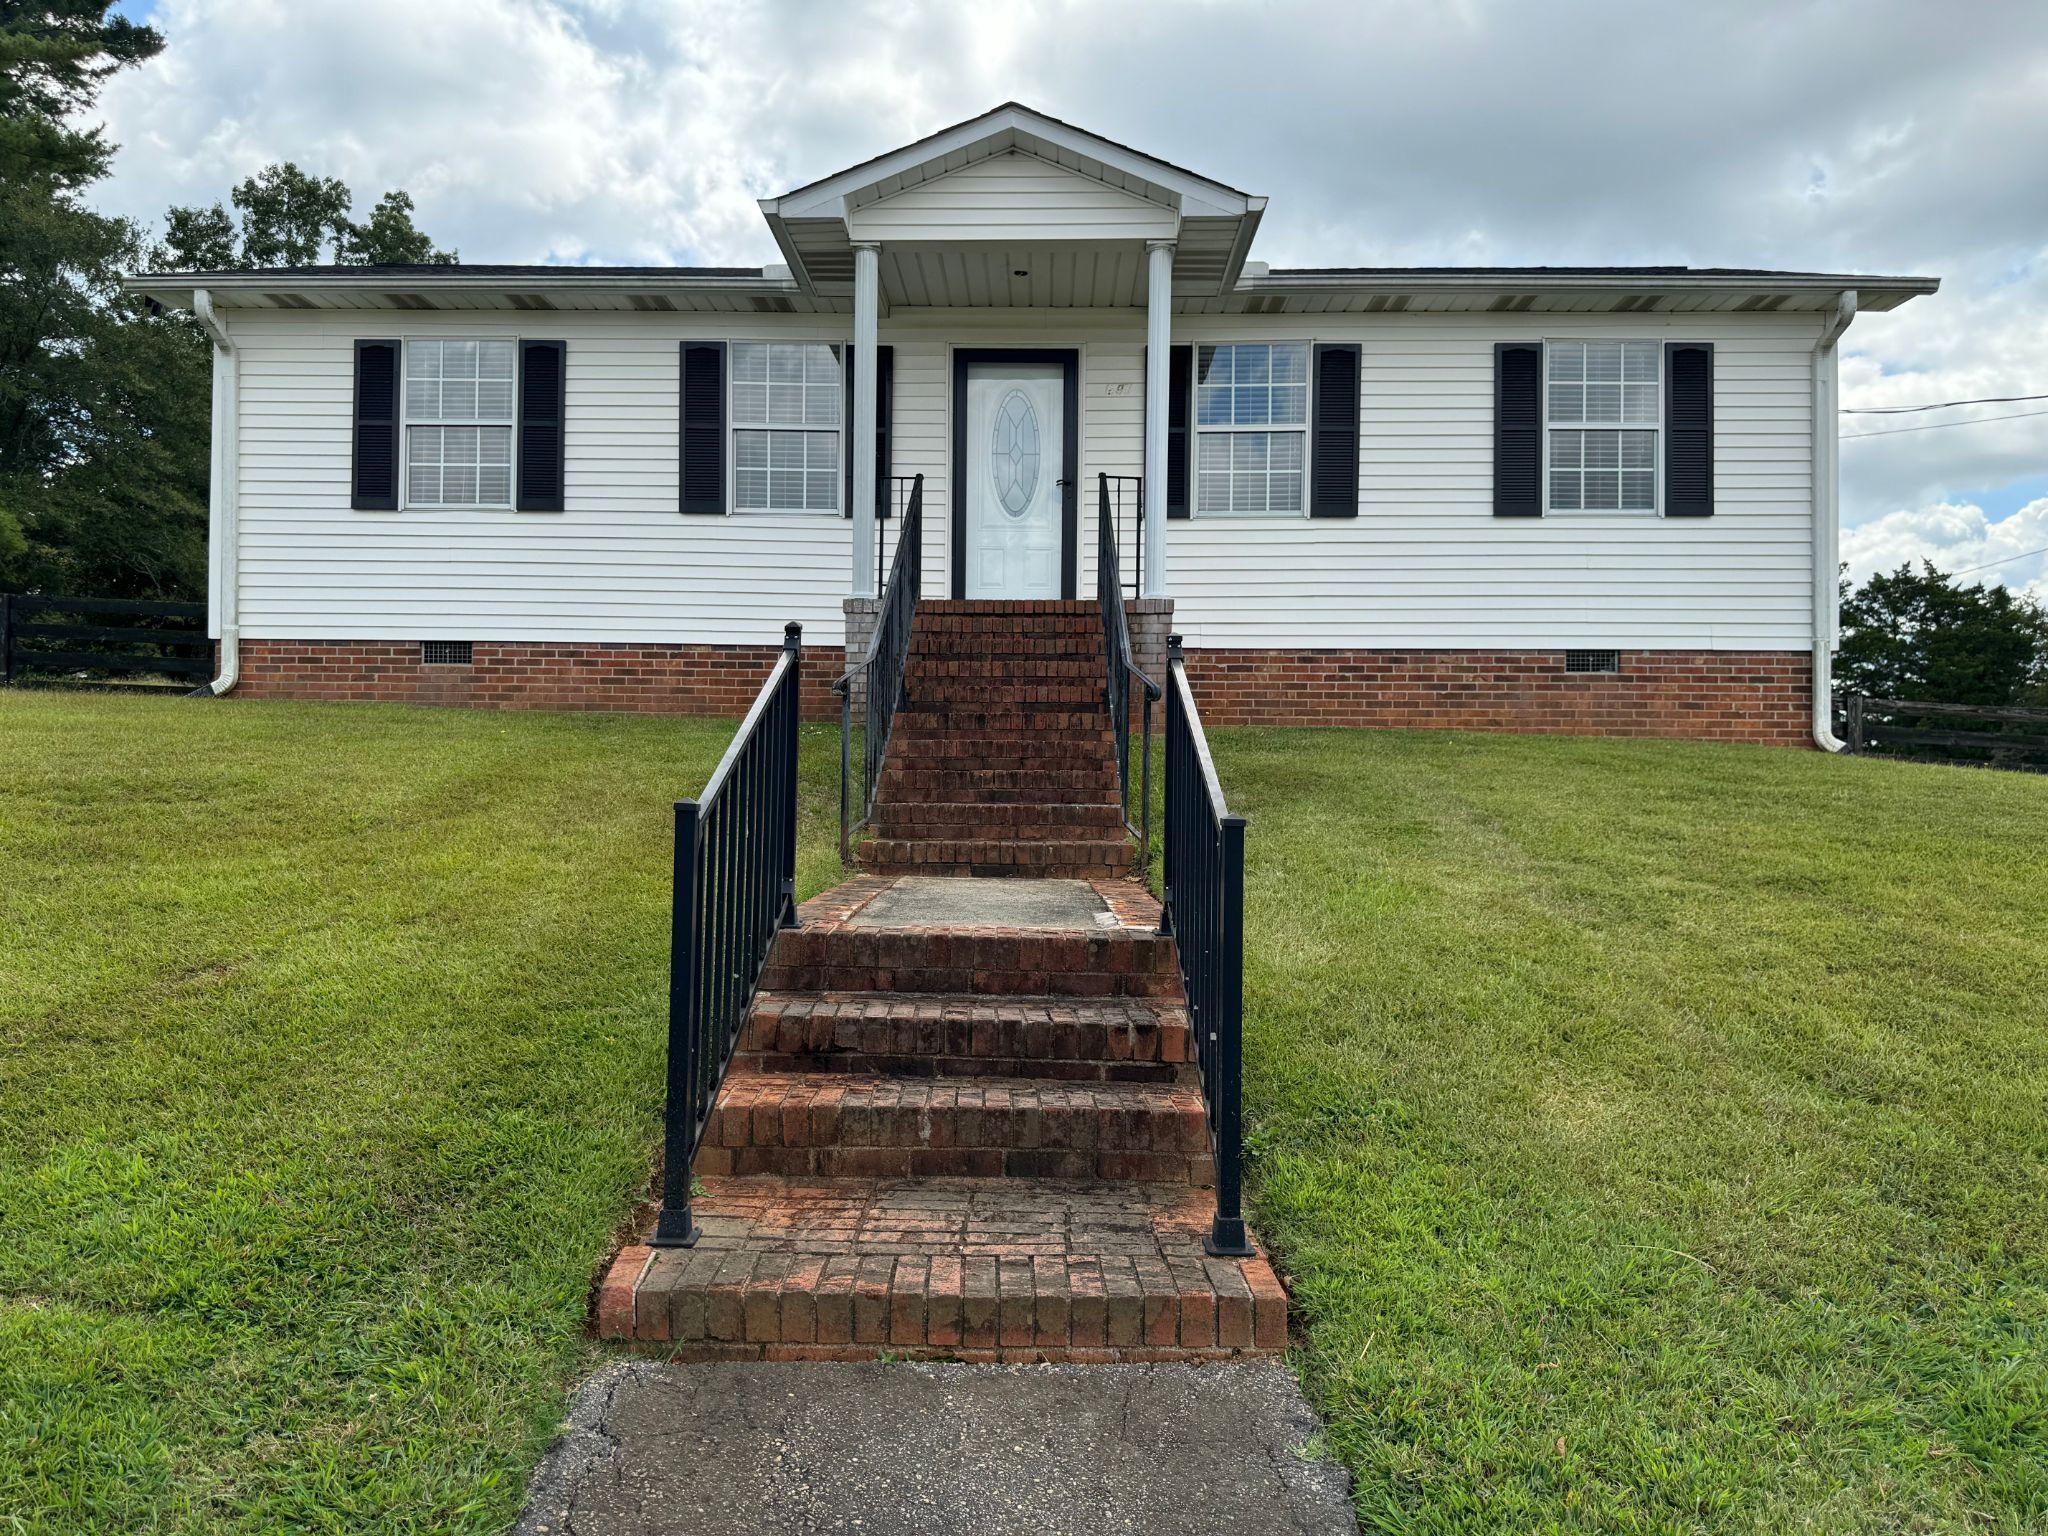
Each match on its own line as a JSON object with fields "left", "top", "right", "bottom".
{"left": 98, "top": 0, "right": 2048, "bottom": 596}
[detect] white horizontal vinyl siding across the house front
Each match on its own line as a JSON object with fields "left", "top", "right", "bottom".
{"left": 215, "top": 309, "right": 1831, "bottom": 651}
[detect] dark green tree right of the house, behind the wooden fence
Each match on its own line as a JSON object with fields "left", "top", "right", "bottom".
{"left": 1835, "top": 561, "right": 2048, "bottom": 707}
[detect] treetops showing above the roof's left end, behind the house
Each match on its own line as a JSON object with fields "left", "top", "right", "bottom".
{"left": 164, "top": 171, "right": 455, "bottom": 272}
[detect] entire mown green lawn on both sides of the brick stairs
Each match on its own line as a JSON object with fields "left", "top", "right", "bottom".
{"left": 0, "top": 690, "right": 2048, "bottom": 1536}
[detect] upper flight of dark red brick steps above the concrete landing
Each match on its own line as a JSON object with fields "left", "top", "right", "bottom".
{"left": 860, "top": 602, "right": 1135, "bottom": 881}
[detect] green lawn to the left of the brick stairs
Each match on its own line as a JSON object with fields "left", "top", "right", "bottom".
{"left": 0, "top": 690, "right": 838, "bottom": 1532}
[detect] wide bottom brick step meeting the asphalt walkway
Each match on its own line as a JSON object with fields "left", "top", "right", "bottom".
{"left": 596, "top": 1178, "right": 1286, "bottom": 1360}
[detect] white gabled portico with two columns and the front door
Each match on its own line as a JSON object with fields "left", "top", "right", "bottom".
{"left": 762, "top": 102, "right": 1266, "bottom": 606}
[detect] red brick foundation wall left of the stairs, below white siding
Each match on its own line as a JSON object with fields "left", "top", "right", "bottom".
{"left": 233, "top": 641, "right": 844, "bottom": 721}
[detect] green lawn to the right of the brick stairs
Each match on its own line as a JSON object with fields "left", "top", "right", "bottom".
{"left": 1217, "top": 731, "right": 2048, "bottom": 1532}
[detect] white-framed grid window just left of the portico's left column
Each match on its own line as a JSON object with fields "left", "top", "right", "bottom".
{"left": 729, "top": 342, "right": 844, "bottom": 512}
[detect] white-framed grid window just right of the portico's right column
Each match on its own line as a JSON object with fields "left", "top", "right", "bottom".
{"left": 1194, "top": 342, "right": 1309, "bottom": 516}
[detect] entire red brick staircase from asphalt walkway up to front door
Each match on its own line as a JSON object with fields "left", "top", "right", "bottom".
{"left": 596, "top": 602, "right": 1286, "bottom": 1360}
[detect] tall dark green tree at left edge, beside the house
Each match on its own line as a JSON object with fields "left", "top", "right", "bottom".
{"left": 0, "top": 0, "right": 207, "bottom": 596}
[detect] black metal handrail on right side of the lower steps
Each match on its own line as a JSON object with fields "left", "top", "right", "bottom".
{"left": 1159, "top": 635, "right": 1251, "bottom": 1255}
